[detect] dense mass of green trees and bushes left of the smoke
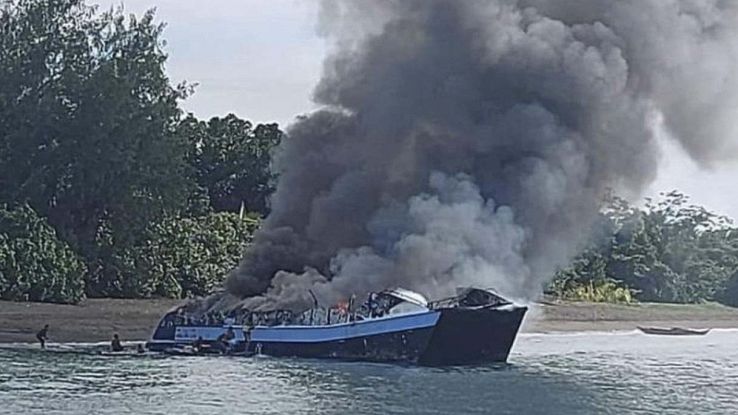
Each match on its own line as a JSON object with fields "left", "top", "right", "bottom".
{"left": 0, "top": 0, "right": 283, "bottom": 303}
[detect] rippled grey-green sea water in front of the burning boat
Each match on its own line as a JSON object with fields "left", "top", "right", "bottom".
{"left": 0, "top": 331, "right": 738, "bottom": 415}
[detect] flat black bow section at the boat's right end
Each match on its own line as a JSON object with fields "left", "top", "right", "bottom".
{"left": 418, "top": 307, "right": 528, "bottom": 366}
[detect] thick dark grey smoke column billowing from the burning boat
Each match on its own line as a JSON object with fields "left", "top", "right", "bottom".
{"left": 226, "top": 0, "right": 738, "bottom": 309}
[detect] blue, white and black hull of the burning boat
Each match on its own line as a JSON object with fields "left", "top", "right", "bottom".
{"left": 147, "top": 294, "right": 527, "bottom": 366}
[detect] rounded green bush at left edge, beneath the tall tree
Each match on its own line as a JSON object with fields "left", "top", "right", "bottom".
{"left": 0, "top": 205, "right": 86, "bottom": 303}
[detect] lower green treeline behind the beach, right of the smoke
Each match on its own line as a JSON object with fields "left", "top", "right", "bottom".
{"left": 549, "top": 192, "right": 738, "bottom": 306}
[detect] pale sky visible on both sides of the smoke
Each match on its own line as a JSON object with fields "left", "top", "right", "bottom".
{"left": 91, "top": 0, "right": 738, "bottom": 220}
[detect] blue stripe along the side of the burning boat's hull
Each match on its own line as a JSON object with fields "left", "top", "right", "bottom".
{"left": 251, "top": 311, "right": 441, "bottom": 343}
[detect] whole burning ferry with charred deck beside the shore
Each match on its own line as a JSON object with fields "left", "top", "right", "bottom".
{"left": 147, "top": 288, "right": 527, "bottom": 366}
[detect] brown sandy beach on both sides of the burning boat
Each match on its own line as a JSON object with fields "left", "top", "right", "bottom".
{"left": 0, "top": 299, "right": 738, "bottom": 343}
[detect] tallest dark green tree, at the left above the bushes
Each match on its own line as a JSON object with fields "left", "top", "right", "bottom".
{"left": 0, "top": 0, "right": 192, "bottom": 295}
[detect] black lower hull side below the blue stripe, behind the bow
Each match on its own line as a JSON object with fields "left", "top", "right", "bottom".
{"left": 248, "top": 327, "right": 434, "bottom": 363}
